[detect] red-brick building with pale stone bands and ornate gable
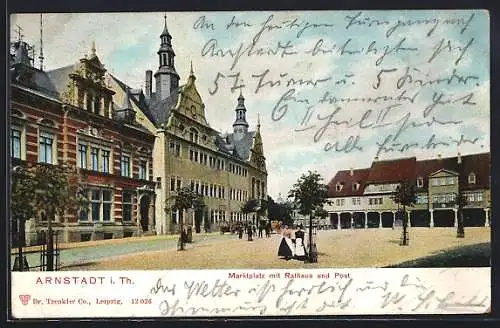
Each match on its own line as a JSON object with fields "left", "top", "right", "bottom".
{"left": 9, "top": 39, "right": 155, "bottom": 245}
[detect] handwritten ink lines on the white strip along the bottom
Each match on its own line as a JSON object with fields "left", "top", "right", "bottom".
{"left": 148, "top": 269, "right": 490, "bottom": 316}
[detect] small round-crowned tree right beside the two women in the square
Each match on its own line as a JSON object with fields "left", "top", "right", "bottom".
{"left": 288, "top": 171, "right": 328, "bottom": 262}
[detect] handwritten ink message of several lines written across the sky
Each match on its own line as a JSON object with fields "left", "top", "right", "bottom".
{"left": 192, "top": 11, "right": 489, "bottom": 156}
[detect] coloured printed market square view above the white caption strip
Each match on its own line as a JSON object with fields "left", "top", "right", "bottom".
{"left": 9, "top": 11, "right": 495, "bottom": 272}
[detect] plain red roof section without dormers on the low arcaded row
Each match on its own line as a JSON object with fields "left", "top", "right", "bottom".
{"left": 367, "top": 157, "right": 417, "bottom": 183}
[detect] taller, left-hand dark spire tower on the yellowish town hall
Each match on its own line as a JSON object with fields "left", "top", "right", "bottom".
{"left": 154, "top": 15, "right": 179, "bottom": 100}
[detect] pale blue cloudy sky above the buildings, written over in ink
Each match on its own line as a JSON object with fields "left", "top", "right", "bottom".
{"left": 10, "top": 10, "right": 490, "bottom": 199}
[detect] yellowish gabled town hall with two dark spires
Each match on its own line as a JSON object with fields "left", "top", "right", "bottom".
{"left": 106, "top": 19, "right": 267, "bottom": 234}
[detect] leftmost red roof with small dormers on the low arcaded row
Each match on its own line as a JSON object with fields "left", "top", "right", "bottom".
{"left": 328, "top": 169, "right": 370, "bottom": 197}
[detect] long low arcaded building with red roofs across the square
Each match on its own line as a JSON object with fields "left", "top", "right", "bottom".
{"left": 325, "top": 153, "right": 491, "bottom": 229}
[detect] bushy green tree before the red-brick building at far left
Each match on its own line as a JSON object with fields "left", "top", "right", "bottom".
{"left": 11, "top": 163, "right": 87, "bottom": 271}
